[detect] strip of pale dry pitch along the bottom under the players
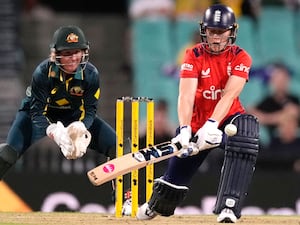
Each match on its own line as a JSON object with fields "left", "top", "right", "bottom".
{"left": 0, "top": 212, "right": 300, "bottom": 225}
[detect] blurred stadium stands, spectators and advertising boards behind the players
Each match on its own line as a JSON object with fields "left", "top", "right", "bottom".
{"left": 0, "top": 0, "right": 300, "bottom": 214}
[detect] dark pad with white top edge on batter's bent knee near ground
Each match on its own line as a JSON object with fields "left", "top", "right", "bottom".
{"left": 148, "top": 178, "right": 189, "bottom": 216}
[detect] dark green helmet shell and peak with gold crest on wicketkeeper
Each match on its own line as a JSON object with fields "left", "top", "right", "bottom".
{"left": 50, "top": 25, "right": 89, "bottom": 51}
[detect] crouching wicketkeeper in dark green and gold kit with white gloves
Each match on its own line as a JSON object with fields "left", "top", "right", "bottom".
{"left": 0, "top": 26, "right": 116, "bottom": 179}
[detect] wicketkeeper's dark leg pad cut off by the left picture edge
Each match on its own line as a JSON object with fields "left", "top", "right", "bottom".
{"left": 0, "top": 143, "right": 19, "bottom": 180}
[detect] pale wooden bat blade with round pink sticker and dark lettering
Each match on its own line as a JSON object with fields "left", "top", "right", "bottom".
{"left": 87, "top": 142, "right": 180, "bottom": 186}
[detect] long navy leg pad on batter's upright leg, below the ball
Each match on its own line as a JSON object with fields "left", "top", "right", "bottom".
{"left": 214, "top": 115, "right": 259, "bottom": 218}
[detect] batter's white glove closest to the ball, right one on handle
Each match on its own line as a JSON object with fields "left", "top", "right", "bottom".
{"left": 195, "top": 119, "right": 223, "bottom": 151}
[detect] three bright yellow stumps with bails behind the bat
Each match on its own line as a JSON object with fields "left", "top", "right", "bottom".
{"left": 115, "top": 96, "right": 154, "bottom": 217}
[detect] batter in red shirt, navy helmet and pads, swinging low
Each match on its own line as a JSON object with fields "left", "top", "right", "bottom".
{"left": 137, "top": 4, "right": 259, "bottom": 223}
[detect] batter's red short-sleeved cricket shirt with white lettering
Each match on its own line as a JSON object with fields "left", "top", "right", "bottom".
{"left": 180, "top": 44, "right": 252, "bottom": 132}
